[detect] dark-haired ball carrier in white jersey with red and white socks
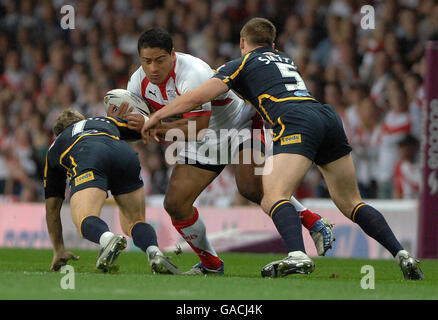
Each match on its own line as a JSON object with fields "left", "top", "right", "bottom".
{"left": 108, "top": 28, "right": 333, "bottom": 274}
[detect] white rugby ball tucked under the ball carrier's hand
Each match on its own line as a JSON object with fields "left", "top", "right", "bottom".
{"left": 103, "top": 89, "right": 151, "bottom": 116}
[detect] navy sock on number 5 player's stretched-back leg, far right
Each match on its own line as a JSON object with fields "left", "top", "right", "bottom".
{"left": 351, "top": 202, "right": 403, "bottom": 257}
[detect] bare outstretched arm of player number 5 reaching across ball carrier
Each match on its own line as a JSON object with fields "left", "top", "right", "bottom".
{"left": 141, "top": 78, "right": 229, "bottom": 141}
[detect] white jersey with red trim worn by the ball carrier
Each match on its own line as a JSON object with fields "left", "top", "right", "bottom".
{"left": 127, "top": 52, "right": 260, "bottom": 131}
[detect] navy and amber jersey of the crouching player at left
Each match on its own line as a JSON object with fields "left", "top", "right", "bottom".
{"left": 44, "top": 117, "right": 141, "bottom": 199}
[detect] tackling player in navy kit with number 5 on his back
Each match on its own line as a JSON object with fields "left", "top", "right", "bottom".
{"left": 142, "top": 18, "right": 424, "bottom": 279}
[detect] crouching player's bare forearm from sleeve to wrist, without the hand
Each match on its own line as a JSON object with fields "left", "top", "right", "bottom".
{"left": 46, "top": 198, "right": 64, "bottom": 251}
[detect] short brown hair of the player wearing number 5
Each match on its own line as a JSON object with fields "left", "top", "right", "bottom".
{"left": 240, "top": 18, "right": 277, "bottom": 46}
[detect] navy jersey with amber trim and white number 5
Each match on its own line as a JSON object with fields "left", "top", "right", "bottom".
{"left": 214, "top": 47, "right": 316, "bottom": 126}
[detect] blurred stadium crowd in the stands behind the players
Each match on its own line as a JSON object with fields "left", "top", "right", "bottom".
{"left": 0, "top": 0, "right": 438, "bottom": 204}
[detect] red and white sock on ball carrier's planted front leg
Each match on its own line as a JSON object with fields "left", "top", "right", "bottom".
{"left": 172, "top": 208, "right": 221, "bottom": 269}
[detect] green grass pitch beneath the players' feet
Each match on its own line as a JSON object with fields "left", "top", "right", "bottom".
{"left": 0, "top": 248, "right": 438, "bottom": 300}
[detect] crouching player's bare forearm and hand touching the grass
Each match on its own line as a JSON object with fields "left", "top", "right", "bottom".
{"left": 46, "top": 197, "right": 79, "bottom": 271}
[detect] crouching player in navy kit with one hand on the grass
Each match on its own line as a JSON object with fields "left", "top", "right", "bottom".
{"left": 44, "top": 110, "right": 180, "bottom": 274}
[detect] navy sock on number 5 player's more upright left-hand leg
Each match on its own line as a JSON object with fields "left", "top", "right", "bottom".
{"left": 269, "top": 200, "right": 306, "bottom": 253}
